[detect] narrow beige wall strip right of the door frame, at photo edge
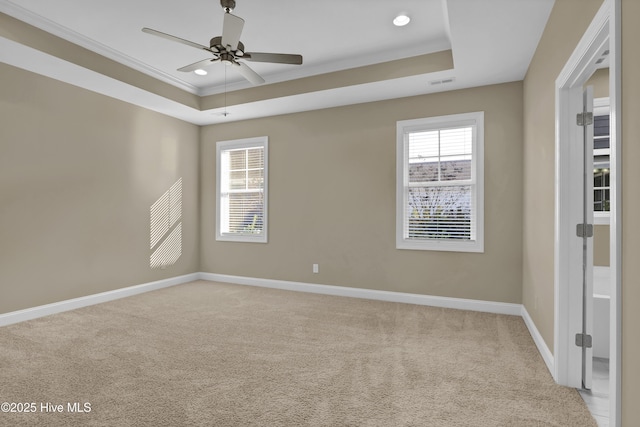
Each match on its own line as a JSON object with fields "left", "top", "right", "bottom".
{"left": 622, "top": 0, "right": 640, "bottom": 427}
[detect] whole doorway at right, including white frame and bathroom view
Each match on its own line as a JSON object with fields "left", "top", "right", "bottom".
{"left": 554, "top": 0, "right": 621, "bottom": 426}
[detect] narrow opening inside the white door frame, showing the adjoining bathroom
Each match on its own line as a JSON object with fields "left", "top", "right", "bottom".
{"left": 580, "top": 82, "right": 612, "bottom": 426}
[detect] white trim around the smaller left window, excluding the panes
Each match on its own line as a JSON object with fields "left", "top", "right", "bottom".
{"left": 216, "top": 136, "right": 269, "bottom": 243}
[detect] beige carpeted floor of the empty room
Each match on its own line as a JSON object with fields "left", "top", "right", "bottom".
{"left": 0, "top": 281, "right": 596, "bottom": 427}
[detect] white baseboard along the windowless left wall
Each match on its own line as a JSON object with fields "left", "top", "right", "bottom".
{"left": 0, "top": 273, "right": 200, "bottom": 326}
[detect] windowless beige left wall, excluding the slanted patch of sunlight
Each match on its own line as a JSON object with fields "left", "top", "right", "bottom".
{"left": 0, "top": 64, "right": 199, "bottom": 313}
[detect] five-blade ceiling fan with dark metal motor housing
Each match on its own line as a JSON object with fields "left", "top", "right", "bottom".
{"left": 142, "top": 0, "right": 302, "bottom": 85}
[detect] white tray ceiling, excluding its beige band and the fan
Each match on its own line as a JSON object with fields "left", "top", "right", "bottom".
{"left": 0, "top": 0, "right": 554, "bottom": 124}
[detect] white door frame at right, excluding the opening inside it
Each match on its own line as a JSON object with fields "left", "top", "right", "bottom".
{"left": 553, "top": 0, "right": 622, "bottom": 427}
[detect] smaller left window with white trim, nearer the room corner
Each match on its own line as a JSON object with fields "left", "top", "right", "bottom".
{"left": 216, "top": 136, "right": 268, "bottom": 243}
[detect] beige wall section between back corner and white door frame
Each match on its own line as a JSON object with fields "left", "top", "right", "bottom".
{"left": 522, "top": 0, "right": 602, "bottom": 351}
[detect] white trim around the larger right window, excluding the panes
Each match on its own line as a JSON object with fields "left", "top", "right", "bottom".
{"left": 396, "top": 111, "right": 484, "bottom": 253}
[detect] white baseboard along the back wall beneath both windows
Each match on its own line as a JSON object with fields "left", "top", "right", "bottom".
{"left": 200, "top": 273, "right": 522, "bottom": 316}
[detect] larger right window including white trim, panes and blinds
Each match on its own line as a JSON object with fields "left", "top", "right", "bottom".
{"left": 396, "top": 112, "right": 484, "bottom": 252}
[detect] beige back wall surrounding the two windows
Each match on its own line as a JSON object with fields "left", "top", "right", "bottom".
{"left": 201, "top": 82, "right": 522, "bottom": 303}
